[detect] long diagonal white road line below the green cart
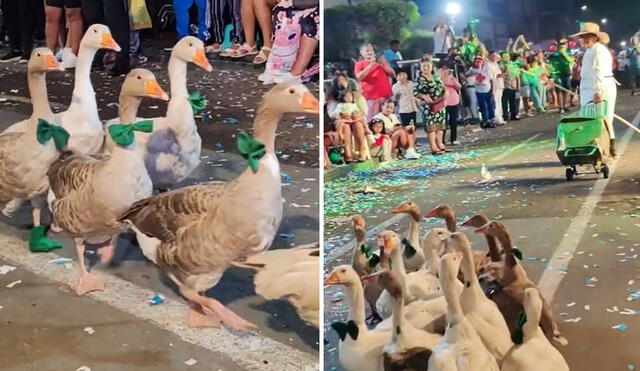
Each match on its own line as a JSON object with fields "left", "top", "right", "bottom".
{"left": 538, "top": 111, "right": 640, "bottom": 302}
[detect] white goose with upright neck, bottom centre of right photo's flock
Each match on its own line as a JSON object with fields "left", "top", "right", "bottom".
{"left": 429, "top": 252, "right": 499, "bottom": 371}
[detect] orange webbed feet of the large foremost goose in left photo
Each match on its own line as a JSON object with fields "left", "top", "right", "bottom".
{"left": 178, "top": 284, "right": 256, "bottom": 330}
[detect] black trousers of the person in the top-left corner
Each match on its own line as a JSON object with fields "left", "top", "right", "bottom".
{"left": 2, "top": 0, "right": 44, "bottom": 56}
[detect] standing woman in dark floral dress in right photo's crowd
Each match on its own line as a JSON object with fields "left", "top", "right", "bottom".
{"left": 413, "top": 62, "right": 447, "bottom": 156}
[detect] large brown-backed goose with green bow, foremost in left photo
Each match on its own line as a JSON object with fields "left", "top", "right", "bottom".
{"left": 120, "top": 85, "right": 318, "bottom": 330}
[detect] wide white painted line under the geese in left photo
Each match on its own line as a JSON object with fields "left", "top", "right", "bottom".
{"left": 0, "top": 234, "right": 320, "bottom": 371}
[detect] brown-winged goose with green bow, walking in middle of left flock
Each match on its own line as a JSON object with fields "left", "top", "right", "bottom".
{"left": 47, "top": 69, "right": 168, "bottom": 295}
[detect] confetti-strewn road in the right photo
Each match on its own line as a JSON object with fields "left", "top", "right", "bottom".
{"left": 325, "top": 92, "right": 640, "bottom": 370}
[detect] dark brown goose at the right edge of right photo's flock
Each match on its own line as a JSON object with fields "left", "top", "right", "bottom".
{"left": 476, "top": 221, "right": 568, "bottom": 345}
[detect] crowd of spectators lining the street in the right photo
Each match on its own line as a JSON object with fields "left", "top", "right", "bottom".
{"left": 324, "top": 18, "right": 640, "bottom": 167}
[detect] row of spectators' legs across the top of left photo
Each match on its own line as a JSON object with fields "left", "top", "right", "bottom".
{"left": 0, "top": 0, "right": 320, "bottom": 83}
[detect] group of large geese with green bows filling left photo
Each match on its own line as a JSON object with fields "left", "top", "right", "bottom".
{"left": 0, "top": 24, "right": 319, "bottom": 330}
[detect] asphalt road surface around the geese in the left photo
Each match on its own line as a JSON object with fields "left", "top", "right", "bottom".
{"left": 0, "top": 61, "right": 319, "bottom": 370}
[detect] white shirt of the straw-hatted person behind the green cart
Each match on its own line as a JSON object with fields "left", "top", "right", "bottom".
{"left": 580, "top": 42, "right": 615, "bottom": 95}
